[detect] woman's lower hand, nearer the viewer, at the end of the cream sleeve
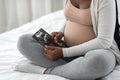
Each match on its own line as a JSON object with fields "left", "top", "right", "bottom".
{"left": 45, "top": 46, "right": 63, "bottom": 61}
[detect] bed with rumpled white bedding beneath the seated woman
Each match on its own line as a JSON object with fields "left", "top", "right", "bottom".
{"left": 0, "top": 10, "right": 120, "bottom": 80}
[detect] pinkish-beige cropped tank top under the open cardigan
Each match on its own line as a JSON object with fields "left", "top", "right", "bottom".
{"left": 64, "top": 0, "right": 92, "bottom": 25}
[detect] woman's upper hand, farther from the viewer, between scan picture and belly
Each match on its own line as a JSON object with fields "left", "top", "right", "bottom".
{"left": 51, "top": 32, "right": 64, "bottom": 46}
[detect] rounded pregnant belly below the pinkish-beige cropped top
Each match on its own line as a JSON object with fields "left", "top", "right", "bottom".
{"left": 64, "top": 21, "right": 95, "bottom": 46}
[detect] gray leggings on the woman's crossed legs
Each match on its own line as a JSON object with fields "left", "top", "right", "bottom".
{"left": 17, "top": 34, "right": 116, "bottom": 80}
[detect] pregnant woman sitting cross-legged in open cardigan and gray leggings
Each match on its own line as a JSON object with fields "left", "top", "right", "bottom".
{"left": 15, "top": 0, "right": 120, "bottom": 80}
